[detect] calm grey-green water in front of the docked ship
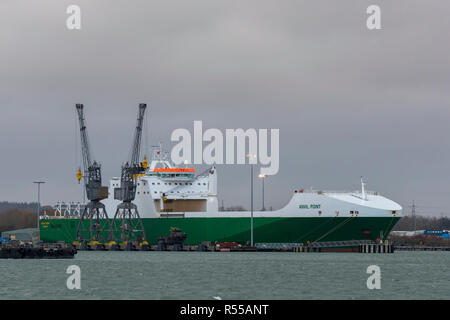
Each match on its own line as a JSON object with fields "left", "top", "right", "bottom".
{"left": 0, "top": 252, "right": 450, "bottom": 300}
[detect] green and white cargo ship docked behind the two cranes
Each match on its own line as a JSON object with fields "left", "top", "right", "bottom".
{"left": 40, "top": 147, "right": 402, "bottom": 245}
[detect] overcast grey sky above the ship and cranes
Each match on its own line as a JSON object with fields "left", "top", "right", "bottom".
{"left": 0, "top": 0, "right": 450, "bottom": 214}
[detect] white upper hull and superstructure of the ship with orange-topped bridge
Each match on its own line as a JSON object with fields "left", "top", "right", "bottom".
{"left": 103, "top": 147, "right": 402, "bottom": 218}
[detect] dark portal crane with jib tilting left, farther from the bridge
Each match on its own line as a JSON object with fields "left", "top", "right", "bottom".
{"left": 76, "top": 104, "right": 111, "bottom": 248}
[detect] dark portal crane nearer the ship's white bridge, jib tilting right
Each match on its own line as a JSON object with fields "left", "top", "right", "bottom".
{"left": 112, "top": 103, "right": 148, "bottom": 250}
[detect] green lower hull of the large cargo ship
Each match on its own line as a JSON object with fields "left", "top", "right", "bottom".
{"left": 40, "top": 217, "right": 400, "bottom": 245}
